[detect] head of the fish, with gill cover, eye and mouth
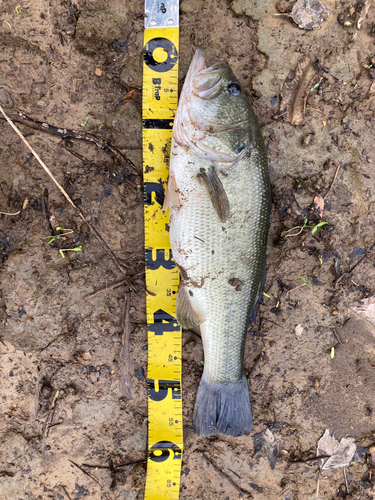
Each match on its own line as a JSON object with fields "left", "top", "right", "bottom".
{"left": 174, "top": 49, "right": 255, "bottom": 162}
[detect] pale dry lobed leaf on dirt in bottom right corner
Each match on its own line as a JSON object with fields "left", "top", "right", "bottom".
{"left": 316, "top": 429, "right": 356, "bottom": 470}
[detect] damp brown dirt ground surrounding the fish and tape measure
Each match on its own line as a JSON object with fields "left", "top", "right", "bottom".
{"left": 0, "top": 0, "right": 375, "bottom": 500}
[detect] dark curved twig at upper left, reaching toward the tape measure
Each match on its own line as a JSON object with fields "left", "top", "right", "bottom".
{"left": 3, "top": 113, "right": 139, "bottom": 175}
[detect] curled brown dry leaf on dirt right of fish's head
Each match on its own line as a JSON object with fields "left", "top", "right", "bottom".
{"left": 280, "top": 56, "right": 316, "bottom": 125}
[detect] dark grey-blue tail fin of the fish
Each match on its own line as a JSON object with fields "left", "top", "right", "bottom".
{"left": 194, "top": 375, "right": 253, "bottom": 437}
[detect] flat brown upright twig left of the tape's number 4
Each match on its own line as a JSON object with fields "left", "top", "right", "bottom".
{"left": 120, "top": 291, "right": 133, "bottom": 399}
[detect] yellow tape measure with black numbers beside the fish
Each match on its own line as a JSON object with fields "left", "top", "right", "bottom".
{"left": 142, "top": 0, "right": 183, "bottom": 500}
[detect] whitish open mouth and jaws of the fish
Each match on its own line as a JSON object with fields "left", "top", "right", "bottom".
{"left": 186, "top": 48, "right": 228, "bottom": 99}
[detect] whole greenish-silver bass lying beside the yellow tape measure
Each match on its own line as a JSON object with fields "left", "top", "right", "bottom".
{"left": 163, "top": 48, "right": 271, "bottom": 437}
